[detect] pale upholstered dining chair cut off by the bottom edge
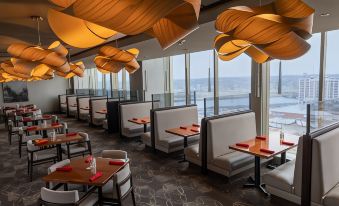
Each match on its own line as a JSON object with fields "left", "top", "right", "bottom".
{"left": 39, "top": 187, "right": 98, "bottom": 206}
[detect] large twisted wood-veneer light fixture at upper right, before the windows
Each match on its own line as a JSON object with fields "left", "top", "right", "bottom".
{"left": 214, "top": 0, "right": 314, "bottom": 63}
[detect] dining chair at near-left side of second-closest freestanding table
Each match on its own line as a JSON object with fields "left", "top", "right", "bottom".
{"left": 27, "top": 140, "right": 58, "bottom": 181}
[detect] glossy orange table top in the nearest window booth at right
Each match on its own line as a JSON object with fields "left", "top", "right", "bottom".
{"left": 229, "top": 132, "right": 299, "bottom": 159}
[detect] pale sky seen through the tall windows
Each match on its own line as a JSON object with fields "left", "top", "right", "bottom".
{"left": 173, "top": 30, "right": 339, "bottom": 79}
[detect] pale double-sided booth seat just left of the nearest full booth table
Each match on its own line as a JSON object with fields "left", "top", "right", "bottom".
{"left": 185, "top": 112, "right": 257, "bottom": 177}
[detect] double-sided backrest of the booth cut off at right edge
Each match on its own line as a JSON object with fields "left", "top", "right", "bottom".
{"left": 293, "top": 128, "right": 339, "bottom": 204}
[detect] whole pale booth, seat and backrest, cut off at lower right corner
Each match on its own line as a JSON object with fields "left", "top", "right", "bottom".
{"left": 263, "top": 125, "right": 339, "bottom": 206}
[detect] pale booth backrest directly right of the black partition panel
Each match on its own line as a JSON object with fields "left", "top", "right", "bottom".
{"left": 120, "top": 102, "right": 152, "bottom": 128}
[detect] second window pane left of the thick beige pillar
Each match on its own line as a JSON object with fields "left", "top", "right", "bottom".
{"left": 190, "top": 50, "right": 214, "bottom": 118}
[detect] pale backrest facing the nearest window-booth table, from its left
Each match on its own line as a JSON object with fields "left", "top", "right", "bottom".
{"left": 207, "top": 112, "right": 257, "bottom": 162}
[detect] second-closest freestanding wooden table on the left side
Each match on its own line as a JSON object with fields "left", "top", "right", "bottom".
{"left": 34, "top": 134, "right": 84, "bottom": 161}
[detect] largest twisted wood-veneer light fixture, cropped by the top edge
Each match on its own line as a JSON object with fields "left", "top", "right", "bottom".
{"left": 48, "top": 0, "right": 201, "bottom": 49}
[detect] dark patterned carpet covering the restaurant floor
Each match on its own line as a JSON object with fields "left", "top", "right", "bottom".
{"left": 0, "top": 116, "right": 292, "bottom": 206}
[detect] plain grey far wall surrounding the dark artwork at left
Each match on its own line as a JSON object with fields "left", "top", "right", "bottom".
{"left": 0, "top": 77, "right": 68, "bottom": 112}
